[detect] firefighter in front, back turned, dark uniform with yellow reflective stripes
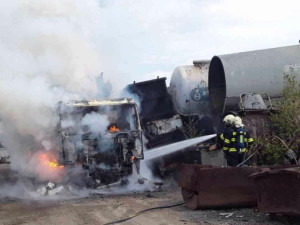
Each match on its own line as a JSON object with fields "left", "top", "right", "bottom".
{"left": 224, "top": 116, "right": 253, "bottom": 166}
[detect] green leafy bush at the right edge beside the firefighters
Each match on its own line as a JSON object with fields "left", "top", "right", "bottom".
{"left": 260, "top": 73, "right": 300, "bottom": 164}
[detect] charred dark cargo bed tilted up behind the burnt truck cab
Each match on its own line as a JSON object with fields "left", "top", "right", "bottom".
{"left": 126, "top": 77, "right": 185, "bottom": 148}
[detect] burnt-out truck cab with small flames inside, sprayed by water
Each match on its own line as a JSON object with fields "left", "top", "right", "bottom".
{"left": 58, "top": 98, "right": 143, "bottom": 187}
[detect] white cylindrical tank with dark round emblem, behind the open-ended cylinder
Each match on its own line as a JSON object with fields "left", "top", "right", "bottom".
{"left": 169, "top": 60, "right": 210, "bottom": 116}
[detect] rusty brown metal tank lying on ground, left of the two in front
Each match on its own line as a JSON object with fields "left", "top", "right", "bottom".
{"left": 178, "top": 164, "right": 259, "bottom": 209}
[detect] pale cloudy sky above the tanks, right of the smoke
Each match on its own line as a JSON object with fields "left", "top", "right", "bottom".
{"left": 97, "top": 0, "right": 300, "bottom": 87}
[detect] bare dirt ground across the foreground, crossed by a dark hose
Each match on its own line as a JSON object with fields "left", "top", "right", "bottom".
{"left": 0, "top": 186, "right": 300, "bottom": 225}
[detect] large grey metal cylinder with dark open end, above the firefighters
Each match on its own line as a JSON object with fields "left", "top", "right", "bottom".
{"left": 208, "top": 45, "right": 300, "bottom": 113}
